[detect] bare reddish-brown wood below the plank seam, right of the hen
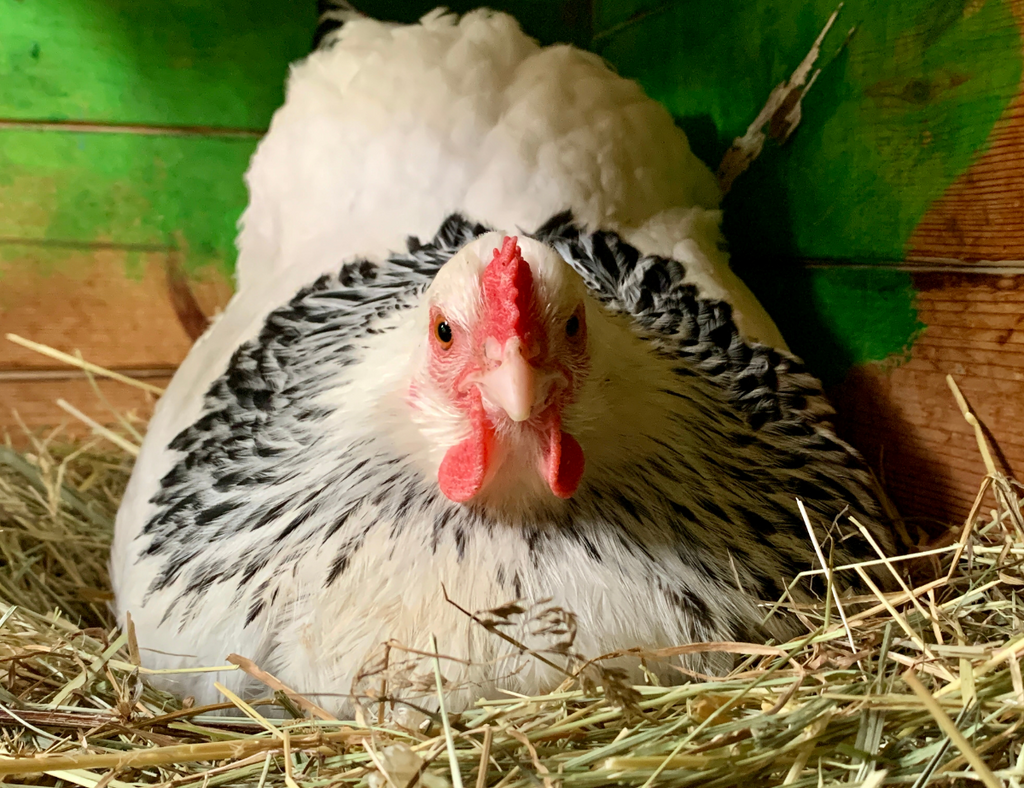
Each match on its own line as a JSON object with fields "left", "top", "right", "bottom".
{"left": 831, "top": 273, "right": 1024, "bottom": 532}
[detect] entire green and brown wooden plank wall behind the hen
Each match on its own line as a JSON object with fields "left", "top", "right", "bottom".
{"left": 0, "top": 0, "right": 1024, "bottom": 524}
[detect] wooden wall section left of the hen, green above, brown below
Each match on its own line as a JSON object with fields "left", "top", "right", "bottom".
{"left": 0, "top": 0, "right": 315, "bottom": 433}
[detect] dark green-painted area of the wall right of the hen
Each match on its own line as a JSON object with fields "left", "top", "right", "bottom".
{"left": 593, "top": 0, "right": 1022, "bottom": 383}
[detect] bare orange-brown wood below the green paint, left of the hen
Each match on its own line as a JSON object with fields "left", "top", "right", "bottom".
{"left": 0, "top": 242, "right": 231, "bottom": 429}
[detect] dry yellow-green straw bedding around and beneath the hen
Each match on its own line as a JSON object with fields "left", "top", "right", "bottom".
{"left": 0, "top": 354, "right": 1024, "bottom": 777}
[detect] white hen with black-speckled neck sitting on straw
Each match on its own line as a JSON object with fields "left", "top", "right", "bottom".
{"left": 112, "top": 7, "right": 891, "bottom": 712}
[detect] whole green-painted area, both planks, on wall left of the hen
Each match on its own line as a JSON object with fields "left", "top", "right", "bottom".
{"left": 0, "top": 0, "right": 315, "bottom": 273}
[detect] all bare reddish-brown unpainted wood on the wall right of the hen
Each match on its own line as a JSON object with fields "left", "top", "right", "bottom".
{"left": 833, "top": 0, "right": 1024, "bottom": 530}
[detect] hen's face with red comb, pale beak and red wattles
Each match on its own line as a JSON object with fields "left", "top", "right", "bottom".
{"left": 411, "top": 233, "right": 590, "bottom": 501}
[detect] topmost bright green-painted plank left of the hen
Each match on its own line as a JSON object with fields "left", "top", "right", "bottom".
{"left": 0, "top": 0, "right": 316, "bottom": 124}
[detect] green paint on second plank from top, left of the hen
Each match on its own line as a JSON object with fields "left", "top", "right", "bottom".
{"left": 0, "top": 130, "right": 256, "bottom": 274}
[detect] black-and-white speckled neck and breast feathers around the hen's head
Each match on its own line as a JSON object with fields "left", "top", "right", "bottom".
{"left": 119, "top": 214, "right": 889, "bottom": 708}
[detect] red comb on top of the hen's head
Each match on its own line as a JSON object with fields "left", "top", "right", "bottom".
{"left": 481, "top": 235, "right": 534, "bottom": 344}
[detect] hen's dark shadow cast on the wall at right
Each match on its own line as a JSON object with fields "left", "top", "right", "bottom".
{"left": 704, "top": 138, "right": 963, "bottom": 535}
